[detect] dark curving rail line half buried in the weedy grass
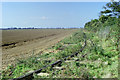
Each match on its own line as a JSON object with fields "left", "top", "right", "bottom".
{"left": 12, "top": 33, "right": 87, "bottom": 80}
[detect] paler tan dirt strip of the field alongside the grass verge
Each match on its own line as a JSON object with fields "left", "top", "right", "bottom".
{"left": 2, "top": 30, "right": 76, "bottom": 69}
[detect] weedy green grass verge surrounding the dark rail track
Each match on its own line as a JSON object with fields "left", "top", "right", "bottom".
{"left": 2, "top": 30, "right": 119, "bottom": 78}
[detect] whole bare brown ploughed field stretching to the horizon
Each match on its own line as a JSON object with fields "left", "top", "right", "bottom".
{"left": 2, "top": 29, "right": 77, "bottom": 69}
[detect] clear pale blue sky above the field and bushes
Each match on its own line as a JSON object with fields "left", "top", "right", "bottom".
{"left": 2, "top": 2, "right": 106, "bottom": 28}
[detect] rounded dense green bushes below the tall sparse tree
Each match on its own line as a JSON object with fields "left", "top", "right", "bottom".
{"left": 84, "top": 15, "right": 119, "bottom": 32}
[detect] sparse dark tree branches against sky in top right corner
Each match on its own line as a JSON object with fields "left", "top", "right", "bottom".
{"left": 100, "top": 0, "right": 120, "bottom": 18}
